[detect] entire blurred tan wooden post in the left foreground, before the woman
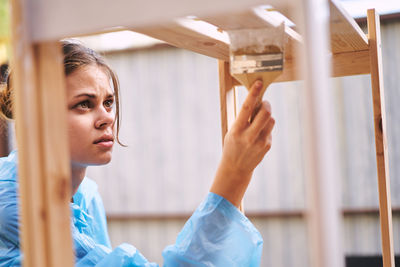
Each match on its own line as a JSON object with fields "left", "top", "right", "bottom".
{"left": 11, "top": 0, "right": 74, "bottom": 267}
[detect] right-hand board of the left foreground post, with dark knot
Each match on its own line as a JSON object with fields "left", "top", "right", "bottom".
{"left": 35, "top": 42, "right": 74, "bottom": 266}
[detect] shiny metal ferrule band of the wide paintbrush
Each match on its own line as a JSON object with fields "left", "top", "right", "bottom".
{"left": 230, "top": 52, "right": 283, "bottom": 74}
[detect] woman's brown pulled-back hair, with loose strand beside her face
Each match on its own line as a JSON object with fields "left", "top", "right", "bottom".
{"left": 0, "top": 40, "right": 125, "bottom": 146}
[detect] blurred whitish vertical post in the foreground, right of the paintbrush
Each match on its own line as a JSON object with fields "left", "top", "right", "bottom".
{"left": 296, "top": 0, "right": 344, "bottom": 267}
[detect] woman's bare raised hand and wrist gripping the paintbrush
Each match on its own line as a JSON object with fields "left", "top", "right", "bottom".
{"left": 210, "top": 81, "right": 275, "bottom": 207}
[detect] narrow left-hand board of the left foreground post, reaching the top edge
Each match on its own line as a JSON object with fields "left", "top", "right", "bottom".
{"left": 11, "top": 0, "right": 48, "bottom": 267}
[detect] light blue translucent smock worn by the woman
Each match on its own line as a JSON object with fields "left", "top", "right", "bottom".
{"left": 0, "top": 151, "right": 263, "bottom": 267}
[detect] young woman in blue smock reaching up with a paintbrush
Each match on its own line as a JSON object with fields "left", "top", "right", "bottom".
{"left": 0, "top": 41, "right": 275, "bottom": 266}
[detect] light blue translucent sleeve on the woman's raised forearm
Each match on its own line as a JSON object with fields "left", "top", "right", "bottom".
{"left": 163, "top": 193, "right": 263, "bottom": 267}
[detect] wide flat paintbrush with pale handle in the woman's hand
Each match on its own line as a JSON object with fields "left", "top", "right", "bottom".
{"left": 228, "top": 23, "right": 285, "bottom": 121}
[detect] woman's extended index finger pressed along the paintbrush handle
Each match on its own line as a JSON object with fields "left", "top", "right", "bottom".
{"left": 235, "top": 80, "right": 263, "bottom": 129}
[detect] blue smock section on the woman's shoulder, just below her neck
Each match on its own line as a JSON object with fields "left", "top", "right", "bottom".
{"left": 71, "top": 178, "right": 158, "bottom": 267}
